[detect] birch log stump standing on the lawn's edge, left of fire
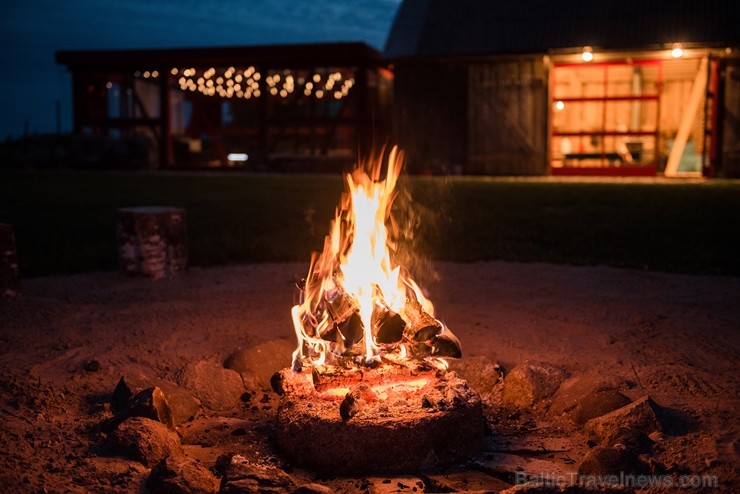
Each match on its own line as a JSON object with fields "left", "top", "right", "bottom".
{"left": 116, "top": 206, "right": 188, "bottom": 279}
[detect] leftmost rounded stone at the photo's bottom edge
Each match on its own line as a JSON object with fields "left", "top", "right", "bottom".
{"left": 146, "top": 455, "right": 219, "bottom": 494}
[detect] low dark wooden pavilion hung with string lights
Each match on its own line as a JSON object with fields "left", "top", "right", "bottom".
{"left": 56, "top": 43, "right": 392, "bottom": 171}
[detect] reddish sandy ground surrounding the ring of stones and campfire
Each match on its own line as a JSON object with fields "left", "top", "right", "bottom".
{"left": 0, "top": 262, "right": 740, "bottom": 492}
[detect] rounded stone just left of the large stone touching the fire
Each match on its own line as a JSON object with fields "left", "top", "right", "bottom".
{"left": 176, "top": 360, "right": 245, "bottom": 411}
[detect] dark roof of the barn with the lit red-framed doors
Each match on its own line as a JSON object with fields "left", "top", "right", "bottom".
{"left": 384, "top": 0, "right": 740, "bottom": 59}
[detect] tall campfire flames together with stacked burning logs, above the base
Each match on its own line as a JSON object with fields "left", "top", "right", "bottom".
{"left": 291, "top": 147, "right": 461, "bottom": 370}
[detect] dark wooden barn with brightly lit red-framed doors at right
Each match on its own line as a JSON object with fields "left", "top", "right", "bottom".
{"left": 384, "top": 0, "right": 740, "bottom": 177}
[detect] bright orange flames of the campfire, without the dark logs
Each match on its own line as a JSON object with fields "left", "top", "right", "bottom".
{"left": 291, "top": 147, "right": 441, "bottom": 369}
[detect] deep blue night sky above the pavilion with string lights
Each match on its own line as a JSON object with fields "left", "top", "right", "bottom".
{"left": 0, "top": 0, "right": 401, "bottom": 139}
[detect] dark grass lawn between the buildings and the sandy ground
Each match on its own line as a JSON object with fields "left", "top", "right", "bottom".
{"left": 0, "top": 171, "right": 740, "bottom": 276}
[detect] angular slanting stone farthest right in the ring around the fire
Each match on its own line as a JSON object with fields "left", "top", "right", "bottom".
{"left": 584, "top": 396, "right": 662, "bottom": 443}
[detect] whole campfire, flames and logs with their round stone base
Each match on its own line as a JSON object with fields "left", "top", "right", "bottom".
{"left": 272, "top": 148, "right": 484, "bottom": 474}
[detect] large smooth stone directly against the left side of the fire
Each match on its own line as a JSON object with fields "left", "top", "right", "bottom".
{"left": 224, "top": 338, "right": 296, "bottom": 387}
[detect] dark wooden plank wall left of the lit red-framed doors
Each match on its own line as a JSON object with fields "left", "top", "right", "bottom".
{"left": 394, "top": 57, "right": 548, "bottom": 175}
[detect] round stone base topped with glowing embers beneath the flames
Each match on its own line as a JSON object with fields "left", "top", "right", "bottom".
{"left": 276, "top": 364, "right": 484, "bottom": 474}
